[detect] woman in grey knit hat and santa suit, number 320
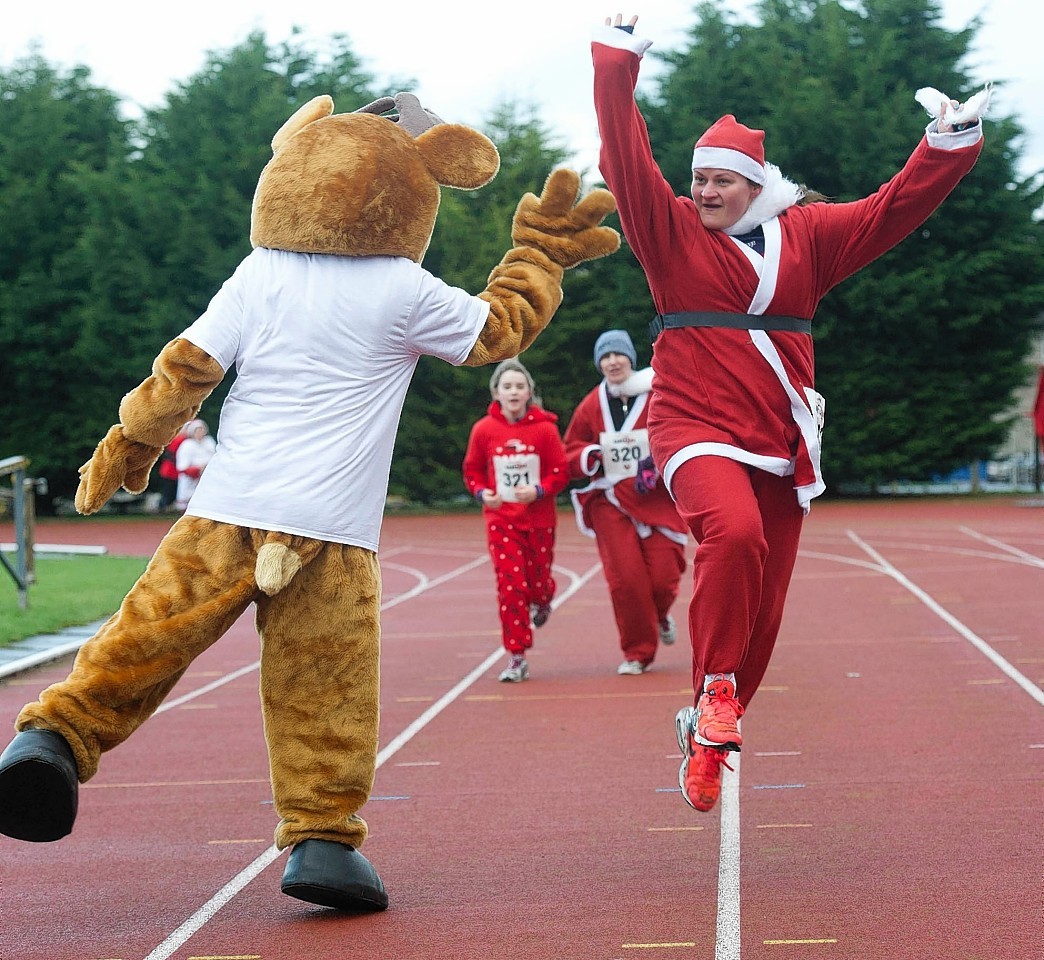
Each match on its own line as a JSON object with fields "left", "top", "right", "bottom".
{"left": 565, "top": 330, "right": 688, "bottom": 676}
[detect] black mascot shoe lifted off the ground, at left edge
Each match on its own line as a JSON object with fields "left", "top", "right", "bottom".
{"left": 0, "top": 729, "right": 79, "bottom": 843}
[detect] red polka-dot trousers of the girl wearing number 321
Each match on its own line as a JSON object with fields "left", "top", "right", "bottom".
{"left": 485, "top": 514, "right": 555, "bottom": 653}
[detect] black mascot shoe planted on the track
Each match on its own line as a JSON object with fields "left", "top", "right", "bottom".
{"left": 281, "top": 840, "right": 388, "bottom": 913}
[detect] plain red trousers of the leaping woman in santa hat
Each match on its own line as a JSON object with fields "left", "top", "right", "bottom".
{"left": 671, "top": 456, "right": 804, "bottom": 706}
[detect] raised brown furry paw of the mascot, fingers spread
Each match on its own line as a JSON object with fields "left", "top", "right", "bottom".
{"left": 512, "top": 169, "right": 620, "bottom": 269}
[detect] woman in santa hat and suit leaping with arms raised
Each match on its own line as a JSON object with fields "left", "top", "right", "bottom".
{"left": 592, "top": 15, "right": 989, "bottom": 810}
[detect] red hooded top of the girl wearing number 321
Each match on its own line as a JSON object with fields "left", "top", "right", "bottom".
{"left": 461, "top": 401, "right": 569, "bottom": 527}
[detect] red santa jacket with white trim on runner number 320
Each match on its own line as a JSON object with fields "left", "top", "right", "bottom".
{"left": 565, "top": 381, "right": 687, "bottom": 543}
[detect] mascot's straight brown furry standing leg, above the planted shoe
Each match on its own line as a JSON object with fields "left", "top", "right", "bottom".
{"left": 257, "top": 544, "right": 381, "bottom": 848}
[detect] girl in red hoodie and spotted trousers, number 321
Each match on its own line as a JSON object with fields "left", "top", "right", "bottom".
{"left": 462, "top": 360, "right": 569, "bottom": 683}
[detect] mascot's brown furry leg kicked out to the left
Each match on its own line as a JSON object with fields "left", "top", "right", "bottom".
{"left": 17, "top": 517, "right": 257, "bottom": 783}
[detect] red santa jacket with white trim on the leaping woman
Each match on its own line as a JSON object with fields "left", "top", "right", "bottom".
{"left": 592, "top": 28, "right": 981, "bottom": 508}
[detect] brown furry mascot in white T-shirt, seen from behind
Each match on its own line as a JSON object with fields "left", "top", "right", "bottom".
{"left": 0, "top": 94, "right": 619, "bottom": 911}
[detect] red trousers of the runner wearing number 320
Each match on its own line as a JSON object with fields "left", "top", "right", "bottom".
{"left": 588, "top": 497, "right": 685, "bottom": 666}
